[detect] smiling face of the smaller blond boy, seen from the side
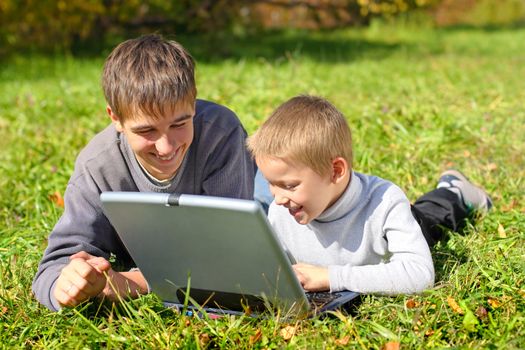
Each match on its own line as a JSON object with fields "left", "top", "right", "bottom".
{"left": 256, "top": 157, "right": 350, "bottom": 225}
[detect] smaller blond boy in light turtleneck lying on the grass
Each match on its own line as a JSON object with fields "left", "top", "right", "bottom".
{"left": 247, "top": 96, "right": 491, "bottom": 294}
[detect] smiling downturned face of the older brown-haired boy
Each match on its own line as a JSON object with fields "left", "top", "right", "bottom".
{"left": 107, "top": 103, "right": 195, "bottom": 180}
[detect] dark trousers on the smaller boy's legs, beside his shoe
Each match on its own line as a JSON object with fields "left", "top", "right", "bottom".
{"left": 412, "top": 188, "right": 469, "bottom": 247}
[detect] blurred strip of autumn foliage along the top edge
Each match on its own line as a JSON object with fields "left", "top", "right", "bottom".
{"left": 0, "top": 0, "right": 525, "bottom": 57}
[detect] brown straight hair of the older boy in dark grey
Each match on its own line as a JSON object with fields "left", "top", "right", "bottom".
{"left": 102, "top": 34, "right": 197, "bottom": 122}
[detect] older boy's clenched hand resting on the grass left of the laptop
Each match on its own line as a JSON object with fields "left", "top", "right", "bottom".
{"left": 53, "top": 252, "right": 111, "bottom": 307}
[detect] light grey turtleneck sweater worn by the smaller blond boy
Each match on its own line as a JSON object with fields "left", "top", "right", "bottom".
{"left": 268, "top": 172, "right": 434, "bottom": 294}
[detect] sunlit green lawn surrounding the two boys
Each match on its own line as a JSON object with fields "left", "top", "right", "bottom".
{"left": 0, "top": 25, "right": 525, "bottom": 349}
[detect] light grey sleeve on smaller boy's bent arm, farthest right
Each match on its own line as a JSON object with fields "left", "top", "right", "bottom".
{"left": 328, "top": 190, "right": 434, "bottom": 295}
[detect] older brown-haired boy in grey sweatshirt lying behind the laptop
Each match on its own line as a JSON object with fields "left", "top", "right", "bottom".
{"left": 33, "top": 35, "right": 255, "bottom": 310}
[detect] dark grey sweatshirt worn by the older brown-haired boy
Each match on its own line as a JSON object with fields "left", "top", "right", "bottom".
{"left": 33, "top": 100, "right": 255, "bottom": 310}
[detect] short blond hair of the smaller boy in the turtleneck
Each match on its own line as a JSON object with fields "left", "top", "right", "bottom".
{"left": 247, "top": 95, "right": 352, "bottom": 176}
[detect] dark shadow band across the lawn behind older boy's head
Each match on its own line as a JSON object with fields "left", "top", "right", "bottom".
{"left": 66, "top": 30, "right": 405, "bottom": 63}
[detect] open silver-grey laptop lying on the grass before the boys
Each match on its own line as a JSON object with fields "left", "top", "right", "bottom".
{"left": 100, "top": 192, "right": 358, "bottom": 317}
